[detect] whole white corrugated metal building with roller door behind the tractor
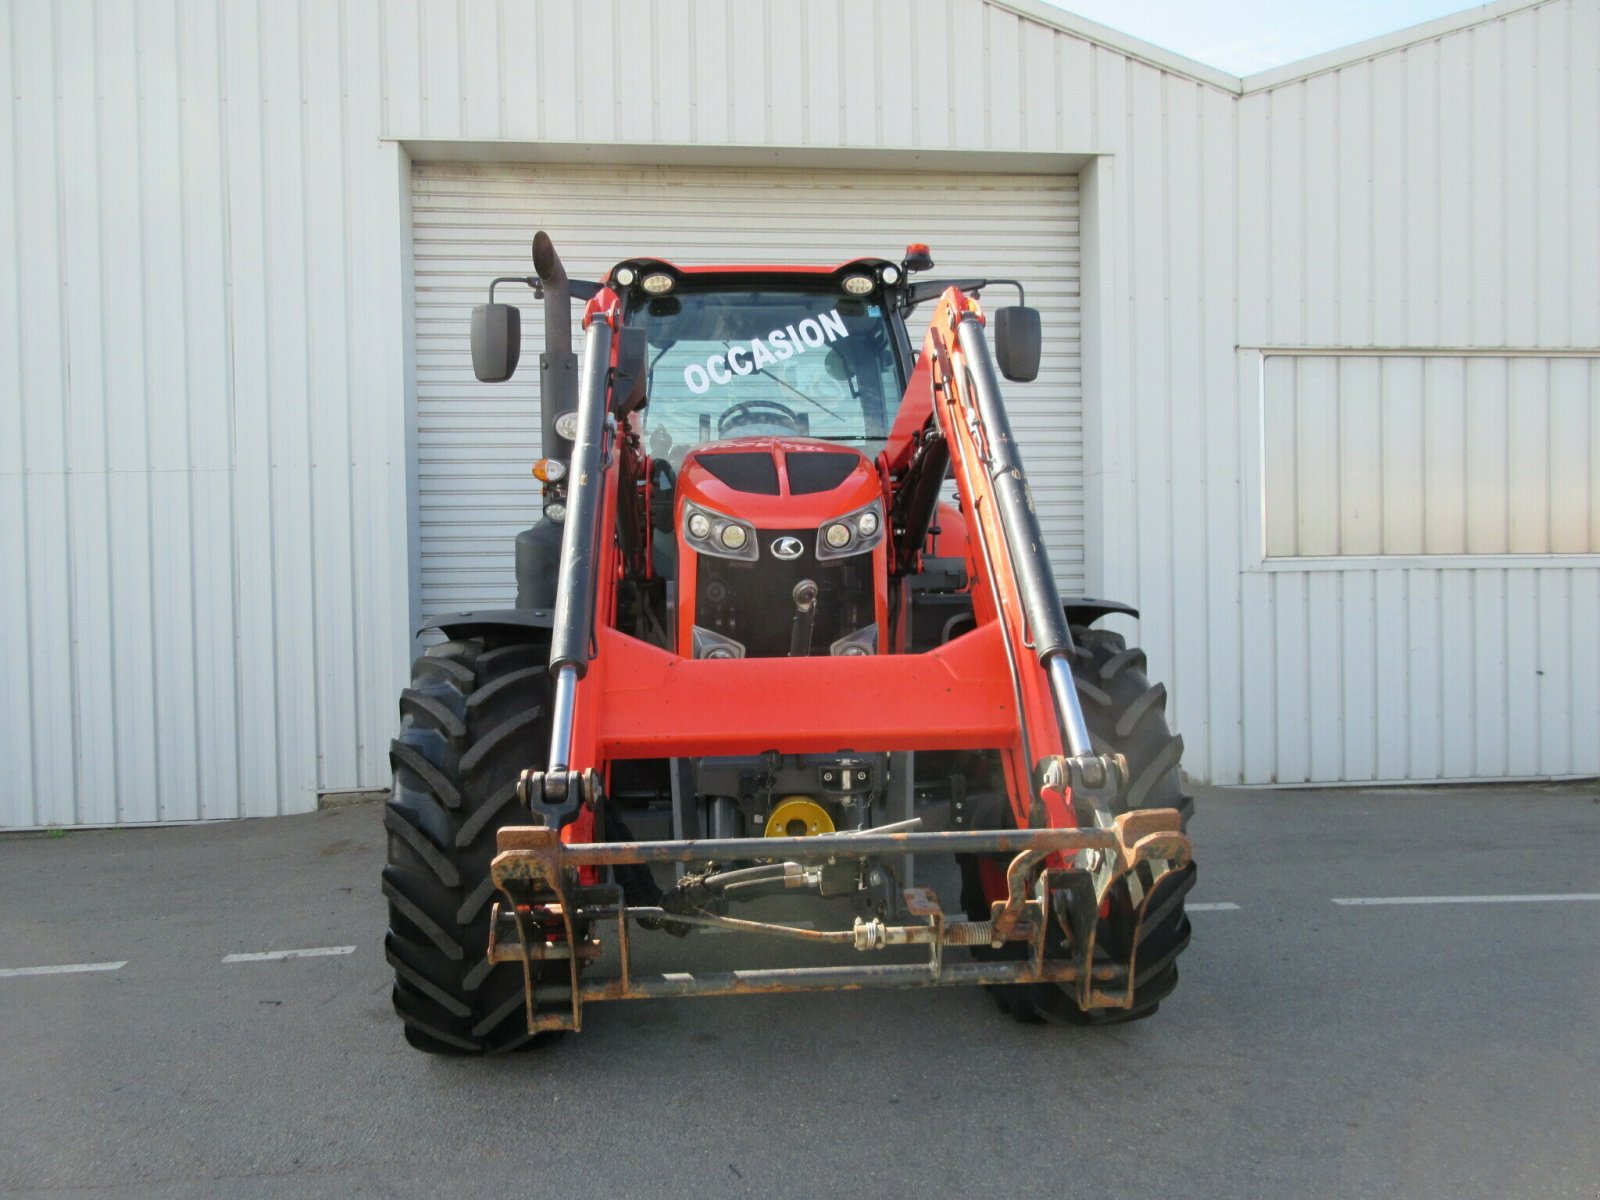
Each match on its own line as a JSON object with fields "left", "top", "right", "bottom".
{"left": 0, "top": 0, "right": 1600, "bottom": 826}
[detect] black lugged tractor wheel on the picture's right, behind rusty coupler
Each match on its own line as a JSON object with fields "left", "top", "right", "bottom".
{"left": 962, "top": 627, "right": 1195, "bottom": 1024}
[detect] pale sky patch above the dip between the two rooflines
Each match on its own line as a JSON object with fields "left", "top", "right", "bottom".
{"left": 1050, "top": 0, "right": 1477, "bottom": 75}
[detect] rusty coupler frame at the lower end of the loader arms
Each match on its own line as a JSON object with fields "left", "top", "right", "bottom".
{"left": 490, "top": 808, "right": 1192, "bottom": 1034}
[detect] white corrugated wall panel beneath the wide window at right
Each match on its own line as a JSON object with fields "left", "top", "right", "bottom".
{"left": 1243, "top": 565, "right": 1600, "bottom": 784}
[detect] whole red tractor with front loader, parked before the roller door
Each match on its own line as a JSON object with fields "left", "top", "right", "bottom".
{"left": 384, "top": 234, "right": 1194, "bottom": 1054}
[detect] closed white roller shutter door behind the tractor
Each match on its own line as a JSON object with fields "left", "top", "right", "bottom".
{"left": 411, "top": 163, "right": 1083, "bottom": 613}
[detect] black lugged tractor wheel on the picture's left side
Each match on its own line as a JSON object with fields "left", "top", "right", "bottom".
{"left": 384, "top": 638, "right": 560, "bottom": 1054}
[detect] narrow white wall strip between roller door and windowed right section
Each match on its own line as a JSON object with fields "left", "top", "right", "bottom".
{"left": 1080, "top": 61, "right": 1262, "bottom": 779}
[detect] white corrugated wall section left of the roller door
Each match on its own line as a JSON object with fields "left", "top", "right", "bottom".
{"left": 0, "top": 0, "right": 410, "bottom": 827}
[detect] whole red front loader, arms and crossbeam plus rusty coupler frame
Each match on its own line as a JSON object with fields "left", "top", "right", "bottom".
{"left": 490, "top": 280, "right": 1189, "bottom": 1030}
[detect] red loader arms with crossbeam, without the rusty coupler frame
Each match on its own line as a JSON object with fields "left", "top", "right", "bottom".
{"left": 530, "top": 288, "right": 1117, "bottom": 840}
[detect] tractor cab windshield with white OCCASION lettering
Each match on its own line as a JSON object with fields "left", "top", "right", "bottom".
{"left": 630, "top": 288, "right": 904, "bottom": 466}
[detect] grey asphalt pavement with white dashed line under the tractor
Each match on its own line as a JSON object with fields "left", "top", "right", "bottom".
{"left": 0, "top": 784, "right": 1600, "bottom": 1200}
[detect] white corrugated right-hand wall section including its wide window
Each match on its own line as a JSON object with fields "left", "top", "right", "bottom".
{"left": 1216, "top": 0, "right": 1600, "bottom": 782}
